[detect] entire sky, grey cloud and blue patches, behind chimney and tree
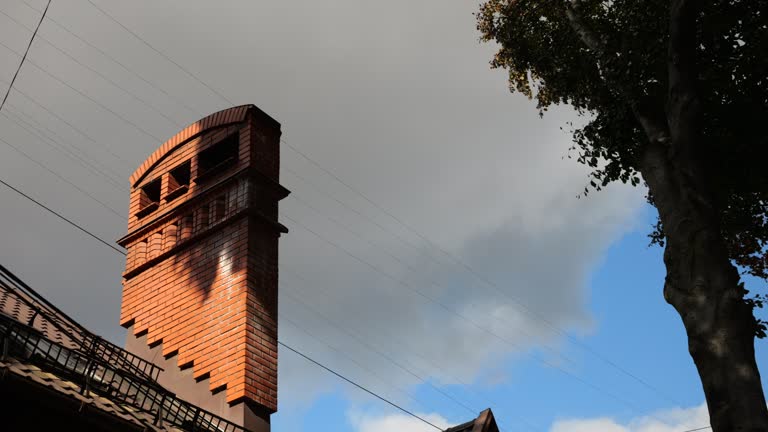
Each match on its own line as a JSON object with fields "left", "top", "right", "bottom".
{"left": 0, "top": 0, "right": 768, "bottom": 432}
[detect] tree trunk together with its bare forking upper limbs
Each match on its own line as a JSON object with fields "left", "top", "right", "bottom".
{"left": 565, "top": 0, "right": 768, "bottom": 426}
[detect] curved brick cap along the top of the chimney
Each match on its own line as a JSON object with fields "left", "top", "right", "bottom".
{"left": 130, "top": 104, "right": 280, "bottom": 186}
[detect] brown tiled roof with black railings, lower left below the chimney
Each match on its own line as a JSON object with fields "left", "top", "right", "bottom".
{"left": 0, "top": 265, "right": 255, "bottom": 432}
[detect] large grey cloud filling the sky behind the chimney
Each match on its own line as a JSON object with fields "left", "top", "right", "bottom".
{"left": 0, "top": 0, "right": 642, "bottom": 418}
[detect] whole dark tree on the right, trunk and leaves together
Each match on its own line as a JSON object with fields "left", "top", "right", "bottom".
{"left": 477, "top": 0, "right": 768, "bottom": 432}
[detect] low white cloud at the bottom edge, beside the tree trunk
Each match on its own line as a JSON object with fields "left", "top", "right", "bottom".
{"left": 550, "top": 403, "right": 709, "bottom": 432}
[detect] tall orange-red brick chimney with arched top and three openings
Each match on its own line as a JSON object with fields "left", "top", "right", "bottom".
{"left": 118, "top": 105, "right": 289, "bottom": 431}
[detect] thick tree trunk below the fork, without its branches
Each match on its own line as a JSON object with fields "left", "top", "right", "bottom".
{"left": 642, "top": 142, "right": 768, "bottom": 432}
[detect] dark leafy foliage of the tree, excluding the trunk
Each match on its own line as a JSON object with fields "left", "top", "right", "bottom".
{"left": 477, "top": 0, "right": 768, "bottom": 296}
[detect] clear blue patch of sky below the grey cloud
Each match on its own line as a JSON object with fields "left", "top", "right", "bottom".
{"left": 273, "top": 207, "right": 768, "bottom": 432}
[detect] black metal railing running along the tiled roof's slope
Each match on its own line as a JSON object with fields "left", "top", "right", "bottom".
{"left": 0, "top": 265, "right": 248, "bottom": 432}
